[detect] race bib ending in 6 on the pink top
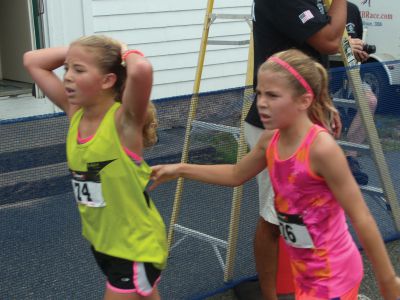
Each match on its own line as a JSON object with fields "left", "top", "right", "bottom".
{"left": 278, "top": 212, "right": 314, "bottom": 248}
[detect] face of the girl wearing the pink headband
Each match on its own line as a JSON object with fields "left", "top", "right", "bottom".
{"left": 256, "top": 71, "right": 300, "bottom": 130}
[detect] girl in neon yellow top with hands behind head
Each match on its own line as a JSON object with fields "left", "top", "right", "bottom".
{"left": 24, "top": 35, "right": 167, "bottom": 300}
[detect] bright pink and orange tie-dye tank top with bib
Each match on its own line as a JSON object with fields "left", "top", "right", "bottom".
{"left": 266, "top": 125, "right": 363, "bottom": 299}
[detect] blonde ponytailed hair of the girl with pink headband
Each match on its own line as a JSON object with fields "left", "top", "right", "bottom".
{"left": 258, "top": 49, "right": 337, "bottom": 131}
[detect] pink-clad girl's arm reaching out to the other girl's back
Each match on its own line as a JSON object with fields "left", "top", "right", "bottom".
{"left": 150, "top": 130, "right": 273, "bottom": 190}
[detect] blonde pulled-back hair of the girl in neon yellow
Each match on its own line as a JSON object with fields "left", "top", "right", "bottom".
{"left": 70, "top": 35, "right": 158, "bottom": 147}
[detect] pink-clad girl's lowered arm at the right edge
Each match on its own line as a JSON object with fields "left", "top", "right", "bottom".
{"left": 310, "top": 133, "right": 400, "bottom": 299}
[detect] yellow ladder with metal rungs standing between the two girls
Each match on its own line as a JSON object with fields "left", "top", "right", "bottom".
{"left": 168, "top": 0, "right": 253, "bottom": 282}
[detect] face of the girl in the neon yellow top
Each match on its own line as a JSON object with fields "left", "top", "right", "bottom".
{"left": 64, "top": 45, "right": 106, "bottom": 106}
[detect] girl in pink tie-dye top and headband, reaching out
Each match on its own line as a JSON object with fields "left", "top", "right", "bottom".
{"left": 151, "top": 50, "right": 400, "bottom": 300}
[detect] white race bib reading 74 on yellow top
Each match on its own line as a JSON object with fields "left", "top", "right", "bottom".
{"left": 71, "top": 179, "right": 106, "bottom": 207}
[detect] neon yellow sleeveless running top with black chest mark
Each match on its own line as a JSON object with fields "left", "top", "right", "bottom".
{"left": 67, "top": 103, "right": 167, "bottom": 269}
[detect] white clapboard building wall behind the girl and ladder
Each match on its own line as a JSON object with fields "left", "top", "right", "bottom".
{"left": 47, "top": 0, "right": 252, "bottom": 99}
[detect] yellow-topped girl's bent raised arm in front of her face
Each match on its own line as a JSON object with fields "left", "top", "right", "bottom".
{"left": 23, "top": 47, "right": 70, "bottom": 115}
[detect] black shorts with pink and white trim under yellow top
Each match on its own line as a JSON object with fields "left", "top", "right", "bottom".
{"left": 91, "top": 247, "right": 161, "bottom": 296}
